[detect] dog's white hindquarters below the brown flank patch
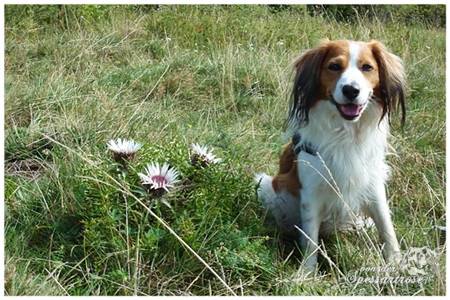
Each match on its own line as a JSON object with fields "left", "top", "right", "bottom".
{"left": 255, "top": 174, "right": 300, "bottom": 234}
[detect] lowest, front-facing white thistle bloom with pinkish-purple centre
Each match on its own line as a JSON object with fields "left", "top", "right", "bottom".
{"left": 138, "top": 163, "right": 180, "bottom": 192}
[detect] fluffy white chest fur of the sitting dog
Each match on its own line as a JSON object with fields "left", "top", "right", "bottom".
{"left": 297, "top": 101, "right": 389, "bottom": 231}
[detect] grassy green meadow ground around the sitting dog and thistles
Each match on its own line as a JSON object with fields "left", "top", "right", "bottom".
{"left": 4, "top": 6, "right": 446, "bottom": 295}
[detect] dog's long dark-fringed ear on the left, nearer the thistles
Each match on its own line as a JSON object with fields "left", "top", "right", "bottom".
{"left": 289, "top": 40, "right": 330, "bottom": 126}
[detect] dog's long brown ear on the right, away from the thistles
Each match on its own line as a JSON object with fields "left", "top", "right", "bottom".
{"left": 371, "top": 41, "right": 406, "bottom": 127}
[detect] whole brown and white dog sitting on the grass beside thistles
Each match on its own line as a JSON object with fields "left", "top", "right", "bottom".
{"left": 256, "top": 40, "right": 406, "bottom": 269}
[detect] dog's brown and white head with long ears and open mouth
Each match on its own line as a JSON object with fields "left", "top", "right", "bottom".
{"left": 290, "top": 40, "right": 406, "bottom": 126}
